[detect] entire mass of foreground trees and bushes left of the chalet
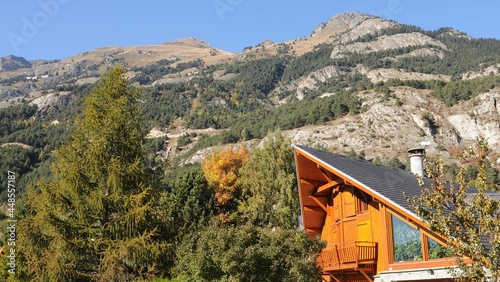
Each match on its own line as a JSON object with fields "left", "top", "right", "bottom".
{"left": 3, "top": 66, "right": 323, "bottom": 281}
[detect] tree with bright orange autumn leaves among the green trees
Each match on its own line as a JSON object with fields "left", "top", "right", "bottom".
{"left": 203, "top": 147, "right": 248, "bottom": 206}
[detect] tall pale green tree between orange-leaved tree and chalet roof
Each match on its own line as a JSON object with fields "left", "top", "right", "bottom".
{"left": 238, "top": 132, "right": 300, "bottom": 228}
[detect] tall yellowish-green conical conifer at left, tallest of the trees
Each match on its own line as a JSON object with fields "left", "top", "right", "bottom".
{"left": 19, "top": 66, "right": 167, "bottom": 281}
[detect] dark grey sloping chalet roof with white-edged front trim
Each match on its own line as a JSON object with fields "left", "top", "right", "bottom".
{"left": 294, "top": 145, "right": 428, "bottom": 223}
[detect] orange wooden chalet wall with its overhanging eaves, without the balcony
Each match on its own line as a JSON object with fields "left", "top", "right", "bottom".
{"left": 296, "top": 148, "right": 454, "bottom": 281}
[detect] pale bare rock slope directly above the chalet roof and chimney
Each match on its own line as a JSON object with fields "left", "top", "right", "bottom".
{"left": 286, "top": 87, "right": 500, "bottom": 163}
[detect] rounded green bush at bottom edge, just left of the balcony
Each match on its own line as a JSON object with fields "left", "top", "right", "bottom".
{"left": 174, "top": 225, "right": 324, "bottom": 282}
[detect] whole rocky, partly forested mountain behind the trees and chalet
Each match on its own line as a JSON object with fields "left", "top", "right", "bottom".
{"left": 0, "top": 13, "right": 500, "bottom": 174}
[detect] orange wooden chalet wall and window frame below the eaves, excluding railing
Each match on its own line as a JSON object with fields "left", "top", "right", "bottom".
{"left": 321, "top": 185, "right": 458, "bottom": 273}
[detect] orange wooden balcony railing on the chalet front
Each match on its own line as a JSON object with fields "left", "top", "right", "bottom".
{"left": 318, "top": 241, "right": 377, "bottom": 270}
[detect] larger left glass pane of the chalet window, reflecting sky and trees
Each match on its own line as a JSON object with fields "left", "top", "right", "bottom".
{"left": 392, "top": 216, "right": 422, "bottom": 262}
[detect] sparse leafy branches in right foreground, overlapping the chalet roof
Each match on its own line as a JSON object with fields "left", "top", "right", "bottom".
{"left": 409, "top": 138, "right": 500, "bottom": 281}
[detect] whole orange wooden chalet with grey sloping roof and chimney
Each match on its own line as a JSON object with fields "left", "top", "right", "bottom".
{"left": 294, "top": 146, "right": 474, "bottom": 282}
